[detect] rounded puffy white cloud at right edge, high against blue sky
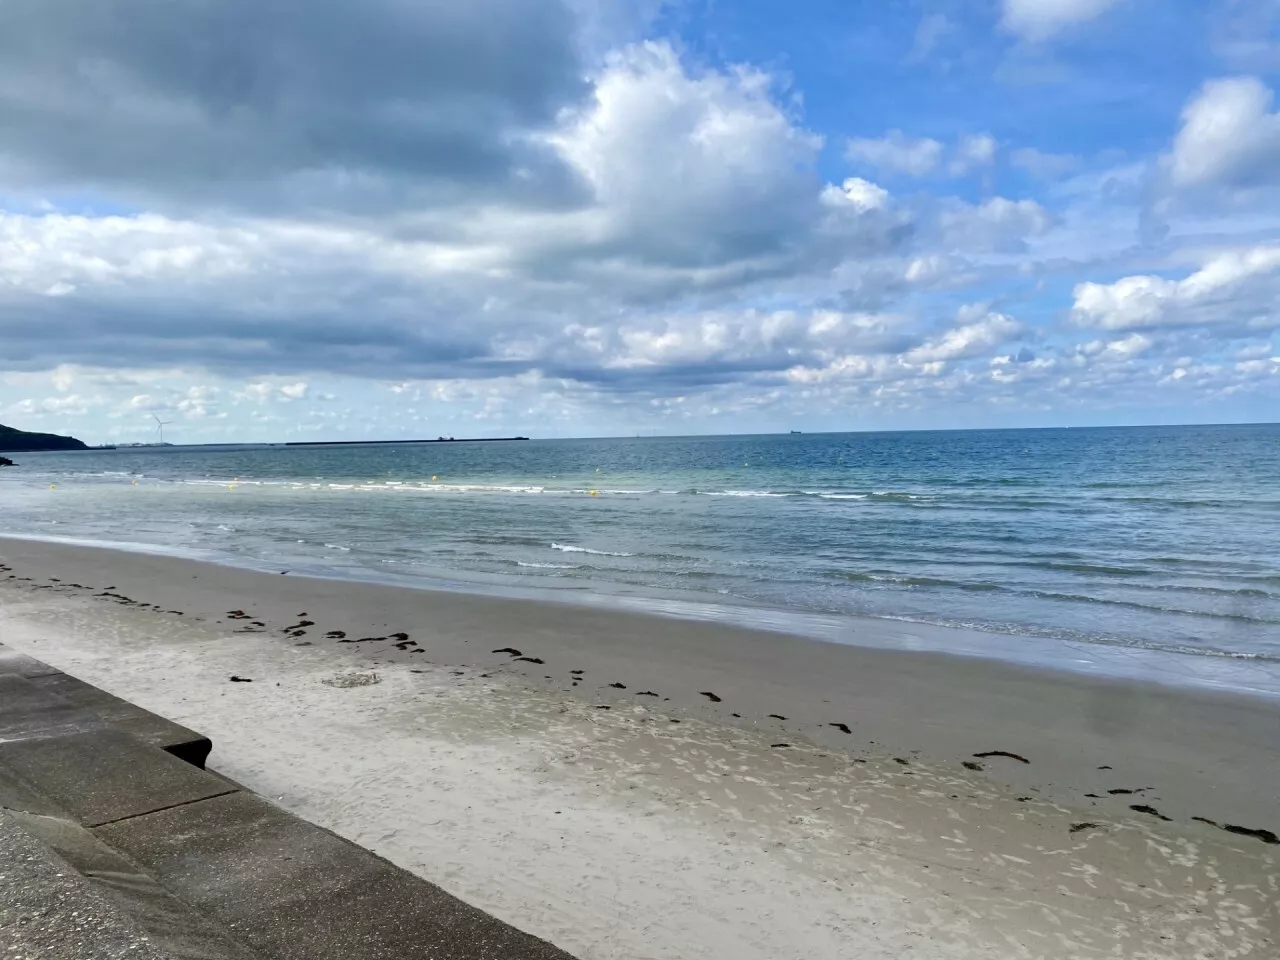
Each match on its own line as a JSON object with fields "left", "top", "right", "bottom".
{"left": 1165, "top": 77, "right": 1280, "bottom": 188}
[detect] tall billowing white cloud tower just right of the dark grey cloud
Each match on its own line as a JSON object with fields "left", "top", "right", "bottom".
{"left": 547, "top": 42, "right": 822, "bottom": 264}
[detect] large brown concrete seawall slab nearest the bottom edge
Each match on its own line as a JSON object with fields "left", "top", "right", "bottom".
{"left": 95, "top": 792, "right": 570, "bottom": 960}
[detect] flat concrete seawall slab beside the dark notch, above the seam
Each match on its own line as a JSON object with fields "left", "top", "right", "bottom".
{"left": 0, "top": 730, "right": 232, "bottom": 827}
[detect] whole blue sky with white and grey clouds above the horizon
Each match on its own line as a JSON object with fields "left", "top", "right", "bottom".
{"left": 0, "top": 0, "right": 1280, "bottom": 443}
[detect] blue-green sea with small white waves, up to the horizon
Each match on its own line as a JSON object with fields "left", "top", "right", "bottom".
{"left": 0, "top": 424, "right": 1280, "bottom": 695}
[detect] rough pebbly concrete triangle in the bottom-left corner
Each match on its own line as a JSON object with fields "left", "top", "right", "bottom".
{"left": 0, "top": 812, "right": 178, "bottom": 960}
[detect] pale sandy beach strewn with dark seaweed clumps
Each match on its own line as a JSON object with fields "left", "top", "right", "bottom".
{"left": 0, "top": 540, "right": 1280, "bottom": 960}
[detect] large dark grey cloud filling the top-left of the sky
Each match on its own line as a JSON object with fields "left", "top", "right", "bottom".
{"left": 0, "top": 0, "right": 588, "bottom": 209}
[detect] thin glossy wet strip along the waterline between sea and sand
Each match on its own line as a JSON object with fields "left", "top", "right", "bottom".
{"left": 0, "top": 532, "right": 1280, "bottom": 700}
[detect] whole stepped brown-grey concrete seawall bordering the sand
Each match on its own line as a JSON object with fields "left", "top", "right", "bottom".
{"left": 0, "top": 645, "right": 572, "bottom": 960}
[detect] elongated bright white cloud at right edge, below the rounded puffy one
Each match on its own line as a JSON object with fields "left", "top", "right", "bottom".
{"left": 1071, "top": 244, "right": 1280, "bottom": 333}
